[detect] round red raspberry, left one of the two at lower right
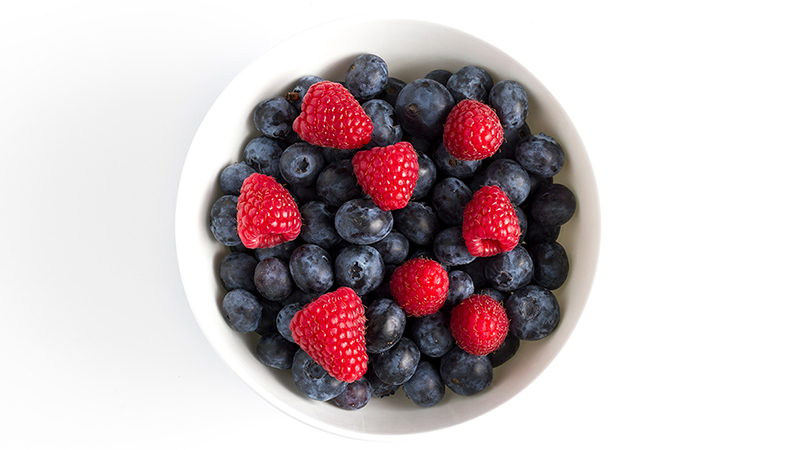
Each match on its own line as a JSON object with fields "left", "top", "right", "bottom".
{"left": 389, "top": 258, "right": 450, "bottom": 317}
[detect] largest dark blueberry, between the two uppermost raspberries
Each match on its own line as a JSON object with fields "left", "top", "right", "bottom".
{"left": 395, "top": 78, "right": 455, "bottom": 139}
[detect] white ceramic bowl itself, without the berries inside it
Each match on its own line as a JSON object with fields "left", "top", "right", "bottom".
{"left": 175, "top": 19, "right": 600, "bottom": 438}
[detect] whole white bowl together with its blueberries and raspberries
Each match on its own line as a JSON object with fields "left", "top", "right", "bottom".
{"left": 176, "top": 16, "right": 597, "bottom": 434}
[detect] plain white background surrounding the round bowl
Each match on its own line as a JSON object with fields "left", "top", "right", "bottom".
{"left": 0, "top": 0, "right": 800, "bottom": 449}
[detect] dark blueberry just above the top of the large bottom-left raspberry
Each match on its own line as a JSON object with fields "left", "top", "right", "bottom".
{"left": 334, "top": 245, "right": 384, "bottom": 295}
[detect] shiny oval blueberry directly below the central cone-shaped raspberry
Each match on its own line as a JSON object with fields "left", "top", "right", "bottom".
{"left": 334, "top": 198, "right": 394, "bottom": 245}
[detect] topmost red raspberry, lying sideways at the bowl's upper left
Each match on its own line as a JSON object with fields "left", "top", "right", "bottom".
{"left": 292, "top": 81, "right": 372, "bottom": 150}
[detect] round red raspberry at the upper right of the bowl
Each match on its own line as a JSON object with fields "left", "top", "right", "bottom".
{"left": 443, "top": 99, "right": 503, "bottom": 161}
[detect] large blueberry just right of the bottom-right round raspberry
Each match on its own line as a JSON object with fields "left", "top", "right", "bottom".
{"left": 505, "top": 285, "right": 561, "bottom": 341}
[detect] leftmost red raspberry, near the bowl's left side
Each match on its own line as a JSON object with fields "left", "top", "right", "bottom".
{"left": 236, "top": 173, "right": 302, "bottom": 248}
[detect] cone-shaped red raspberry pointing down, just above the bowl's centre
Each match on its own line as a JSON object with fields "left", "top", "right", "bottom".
{"left": 353, "top": 142, "right": 419, "bottom": 211}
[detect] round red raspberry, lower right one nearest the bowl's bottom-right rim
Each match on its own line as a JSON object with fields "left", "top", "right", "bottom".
{"left": 450, "top": 294, "right": 509, "bottom": 355}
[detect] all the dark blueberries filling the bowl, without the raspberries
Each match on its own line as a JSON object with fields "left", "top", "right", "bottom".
{"left": 210, "top": 55, "right": 576, "bottom": 410}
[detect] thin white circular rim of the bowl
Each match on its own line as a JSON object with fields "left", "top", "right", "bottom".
{"left": 174, "top": 14, "right": 600, "bottom": 441}
